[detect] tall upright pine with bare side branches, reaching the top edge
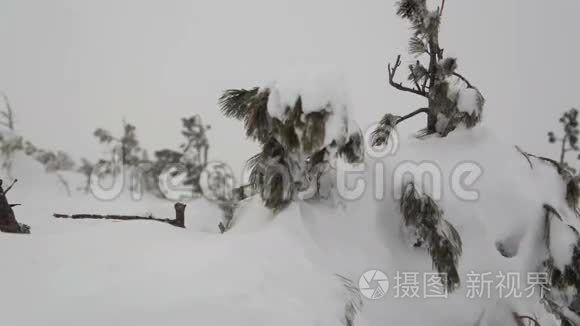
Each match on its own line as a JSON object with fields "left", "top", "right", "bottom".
{"left": 372, "top": 0, "right": 485, "bottom": 146}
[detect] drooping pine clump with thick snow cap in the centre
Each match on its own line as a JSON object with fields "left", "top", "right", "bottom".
{"left": 219, "top": 82, "right": 364, "bottom": 211}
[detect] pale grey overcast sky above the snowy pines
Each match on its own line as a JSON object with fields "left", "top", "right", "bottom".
{"left": 0, "top": 0, "right": 580, "bottom": 173}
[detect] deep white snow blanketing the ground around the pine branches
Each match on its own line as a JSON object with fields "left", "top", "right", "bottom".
{"left": 0, "top": 127, "right": 578, "bottom": 326}
